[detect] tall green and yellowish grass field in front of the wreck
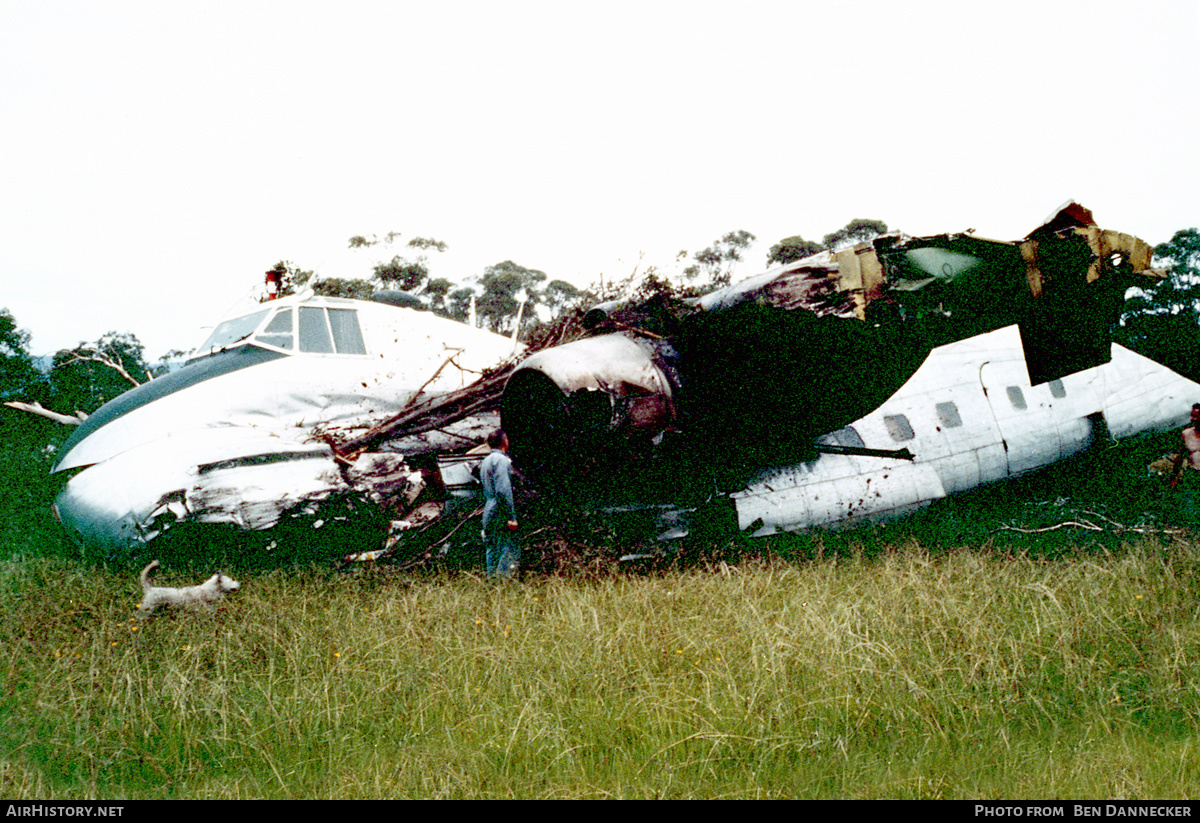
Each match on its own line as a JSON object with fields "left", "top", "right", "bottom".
{"left": 0, "top": 424, "right": 1200, "bottom": 799}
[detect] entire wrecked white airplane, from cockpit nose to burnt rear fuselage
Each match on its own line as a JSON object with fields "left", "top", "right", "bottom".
{"left": 46, "top": 203, "right": 1200, "bottom": 554}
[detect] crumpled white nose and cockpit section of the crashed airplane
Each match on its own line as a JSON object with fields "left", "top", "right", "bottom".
{"left": 53, "top": 292, "right": 516, "bottom": 555}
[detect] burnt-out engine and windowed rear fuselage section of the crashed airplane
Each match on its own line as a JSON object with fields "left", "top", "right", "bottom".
{"left": 500, "top": 202, "right": 1200, "bottom": 537}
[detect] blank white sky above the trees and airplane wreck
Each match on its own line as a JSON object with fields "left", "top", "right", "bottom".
{"left": 0, "top": 0, "right": 1200, "bottom": 360}
